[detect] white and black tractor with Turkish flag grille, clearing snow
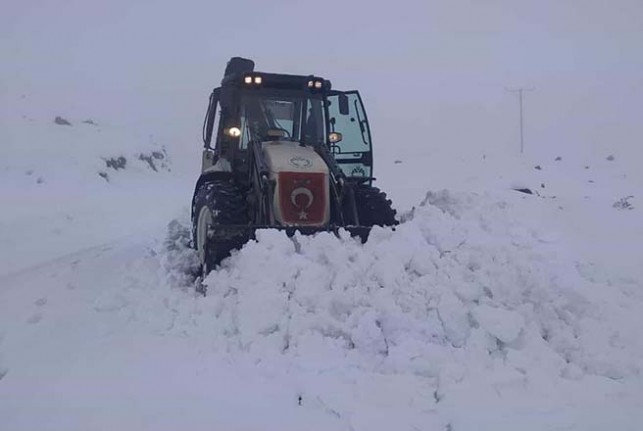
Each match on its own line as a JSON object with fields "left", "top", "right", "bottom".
{"left": 192, "top": 57, "right": 398, "bottom": 277}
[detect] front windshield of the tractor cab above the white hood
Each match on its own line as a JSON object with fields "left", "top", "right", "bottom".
{"left": 241, "top": 92, "right": 326, "bottom": 148}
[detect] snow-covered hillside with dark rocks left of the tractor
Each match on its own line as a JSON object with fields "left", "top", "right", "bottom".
{"left": 0, "top": 96, "right": 196, "bottom": 274}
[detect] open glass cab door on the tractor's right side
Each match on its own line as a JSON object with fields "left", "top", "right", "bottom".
{"left": 326, "top": 91, "right": 373, "bottom": 183}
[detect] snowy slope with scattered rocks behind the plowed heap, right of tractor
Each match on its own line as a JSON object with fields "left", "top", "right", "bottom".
{"left": 375, "top": 145, "right": 643, "bottom": 283}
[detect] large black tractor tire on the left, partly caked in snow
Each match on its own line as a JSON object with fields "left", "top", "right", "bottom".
{"left": 192, "top": 180, "right": 248, "bottom": 278}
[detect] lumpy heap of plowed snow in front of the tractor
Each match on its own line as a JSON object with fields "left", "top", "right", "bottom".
{"left": 199, "top": 192, "right": 641, "bottom": 379}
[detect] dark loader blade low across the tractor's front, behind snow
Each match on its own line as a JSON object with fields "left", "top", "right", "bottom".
{"left": 208, "top": 225, "right": 371, "bottom": 245}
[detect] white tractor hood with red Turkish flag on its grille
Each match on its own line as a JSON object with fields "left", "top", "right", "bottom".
{"left": 263, "top": 141, "right": 330, "bottom": 230}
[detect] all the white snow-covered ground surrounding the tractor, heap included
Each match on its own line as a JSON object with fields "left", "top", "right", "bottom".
{"left": 0, "top": 95, "right": 643, "bottom": 431}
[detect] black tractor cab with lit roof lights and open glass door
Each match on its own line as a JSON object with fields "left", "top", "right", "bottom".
{"left": 202, "top": 58, "right": 373, "bottom": 183}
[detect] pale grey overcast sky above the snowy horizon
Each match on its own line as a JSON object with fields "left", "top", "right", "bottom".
{"left": 0, "top": 0, "right": 643, "bottom": 159}
